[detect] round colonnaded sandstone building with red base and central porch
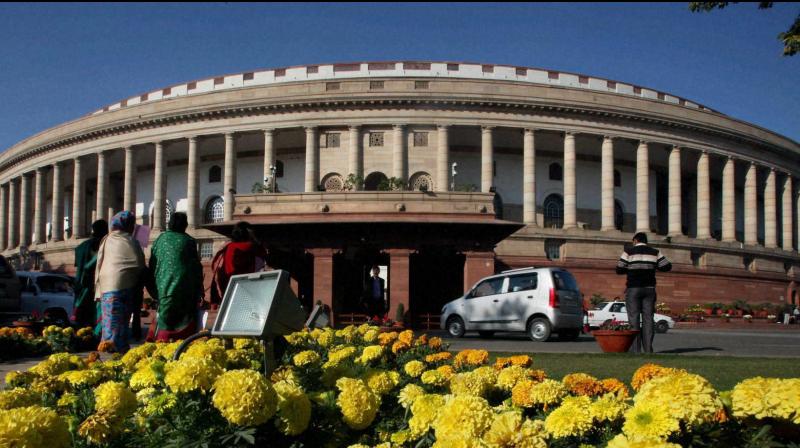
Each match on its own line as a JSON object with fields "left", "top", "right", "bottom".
{"left": 0, "top": 62, "right": 800, "bottom": 324}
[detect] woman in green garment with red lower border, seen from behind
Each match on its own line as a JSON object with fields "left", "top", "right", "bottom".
{"left": 150, "top": 213, "right": 203, "bottom": 342}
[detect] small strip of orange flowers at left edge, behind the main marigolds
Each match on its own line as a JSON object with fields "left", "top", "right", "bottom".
{"left": 0, "top": 325, "right": 94, "bottom": 361}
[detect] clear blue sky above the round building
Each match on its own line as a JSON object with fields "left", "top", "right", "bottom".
{"left": 0, "top": 2, "right": 800, "bottom": 150}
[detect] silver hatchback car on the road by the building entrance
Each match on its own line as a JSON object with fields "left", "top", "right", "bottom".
{"left": 440, "top": 268, "right": 583, "bottom": 342}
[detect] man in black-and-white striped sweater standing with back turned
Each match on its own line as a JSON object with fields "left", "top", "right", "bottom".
{"left": 617, "top": 232, "right": 672, "bottom": 353}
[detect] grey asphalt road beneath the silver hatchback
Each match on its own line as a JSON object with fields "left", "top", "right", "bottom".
{"left": 440, "top": 329, "right": 800, "bottom": 358}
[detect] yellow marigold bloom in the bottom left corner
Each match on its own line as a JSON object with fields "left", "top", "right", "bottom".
{"left": 0, "top": 406, "right": 71, "bottom": 448}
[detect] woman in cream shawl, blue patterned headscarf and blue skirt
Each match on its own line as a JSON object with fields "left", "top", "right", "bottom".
{"left": 94, "top": 211, "right": 146, "bottom": 353}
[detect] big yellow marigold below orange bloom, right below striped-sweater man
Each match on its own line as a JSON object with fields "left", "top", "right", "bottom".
{"left": 628, "top": 372, "right": 723, "bottom": 428}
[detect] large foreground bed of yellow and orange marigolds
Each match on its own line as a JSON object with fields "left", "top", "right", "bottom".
{"left": 0, "top": 325, "right": 800, "bottom": 448}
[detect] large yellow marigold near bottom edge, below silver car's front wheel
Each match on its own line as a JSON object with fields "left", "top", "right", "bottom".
{"left": 432, "top": 395, "right": 493, "bottom": 440}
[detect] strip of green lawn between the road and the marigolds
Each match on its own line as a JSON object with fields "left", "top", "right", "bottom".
{"left": 490, "top": 352, "right": 800, "bottom": 391}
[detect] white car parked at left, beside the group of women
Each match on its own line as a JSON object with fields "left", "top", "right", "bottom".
{"left": 17, "top": 271, "right": 75, "bottom": 326}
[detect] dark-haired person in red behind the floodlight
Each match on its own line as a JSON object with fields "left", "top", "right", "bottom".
{"left": 210, "top": 221, "right": 267, "bottom": 308}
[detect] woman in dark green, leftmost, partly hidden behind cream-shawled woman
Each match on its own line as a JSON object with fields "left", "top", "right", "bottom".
{"left": 73, "top": 219, "right": 108, "bottom": 330}
